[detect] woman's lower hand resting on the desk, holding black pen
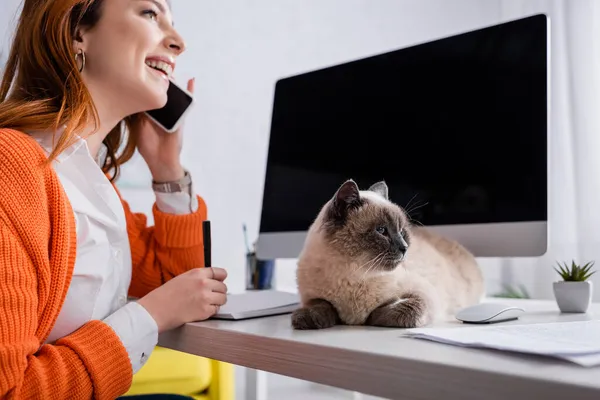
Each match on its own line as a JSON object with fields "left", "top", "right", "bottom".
{"left": 138, "top": 267, "right": 227, "bottom": 333}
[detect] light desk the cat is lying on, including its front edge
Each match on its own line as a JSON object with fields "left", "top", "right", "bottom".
{"left": 159, "top": 299, "right": 600, "bottom": 399}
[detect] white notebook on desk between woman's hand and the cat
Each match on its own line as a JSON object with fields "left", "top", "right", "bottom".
{"left": 212, "top": 290, "right": 300, "bottom": 320}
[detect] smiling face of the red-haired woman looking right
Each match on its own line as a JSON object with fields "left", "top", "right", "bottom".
{"left": 74, "top": 0, "right": 185, "bottom": 117}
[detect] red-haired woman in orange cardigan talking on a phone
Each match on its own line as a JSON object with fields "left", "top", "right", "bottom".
{"left": 0, "top": 0, "right": 227, "bottom": 399}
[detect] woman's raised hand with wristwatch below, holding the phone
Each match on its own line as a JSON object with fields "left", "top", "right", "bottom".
{"left": 137, "top": 79, "right": 194, "bottom": 182}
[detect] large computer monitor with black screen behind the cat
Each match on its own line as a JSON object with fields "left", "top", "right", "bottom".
{"left": 257, "top": 15, "right": 549, "bottom": 259}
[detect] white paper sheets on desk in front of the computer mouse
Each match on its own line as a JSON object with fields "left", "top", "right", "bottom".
{"left": 407, "top": 321, "right": 600, "bottom": 366}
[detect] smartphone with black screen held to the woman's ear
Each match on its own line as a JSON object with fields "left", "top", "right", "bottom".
{"left": 146, "top": 81, "right": 194, "bottom": 133}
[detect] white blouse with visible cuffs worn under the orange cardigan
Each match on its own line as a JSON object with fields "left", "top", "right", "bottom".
{"left": 32, "top": 134, "right": 198, "bottom": 374}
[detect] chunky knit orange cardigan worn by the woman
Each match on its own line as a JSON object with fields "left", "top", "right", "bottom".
{"left": 0, "top": 129, "right": 207, "bottom": 399}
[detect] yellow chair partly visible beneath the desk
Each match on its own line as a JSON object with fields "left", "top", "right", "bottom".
{"left": 125, "top": 346, "right": 235, "bottom": 400}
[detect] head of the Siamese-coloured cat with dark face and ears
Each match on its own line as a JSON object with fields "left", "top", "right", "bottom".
{"left": 321, "top": 180, "right": 410, "bottom": 271}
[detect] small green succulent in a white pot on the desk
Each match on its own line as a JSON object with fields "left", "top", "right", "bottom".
{"left": 553, "top": 261, "right": 596, "bottom": 313}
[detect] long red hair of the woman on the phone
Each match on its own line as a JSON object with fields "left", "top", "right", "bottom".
{"left": 0, "top": 0, "right": 139, "bottom": 180}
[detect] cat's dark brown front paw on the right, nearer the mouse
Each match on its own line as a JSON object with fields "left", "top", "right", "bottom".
{"left": 365, "top": 296, "right": 426, "bottom": 328}
